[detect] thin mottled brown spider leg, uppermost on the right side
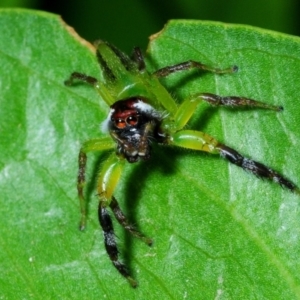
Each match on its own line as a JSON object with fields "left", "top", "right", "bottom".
{"left": 153, "top": 60, "right": 238, "bottom": 77}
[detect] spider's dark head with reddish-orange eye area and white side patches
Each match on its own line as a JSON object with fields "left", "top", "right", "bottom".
{"left": 104, "top": 97, "right": 161, "bottom": 162}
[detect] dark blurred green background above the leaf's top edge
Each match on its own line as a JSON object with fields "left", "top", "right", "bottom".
{"left": 0, "top": 0, "right": 300, "bottom": 52}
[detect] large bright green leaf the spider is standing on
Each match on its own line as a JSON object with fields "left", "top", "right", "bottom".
{"left": 0, "top": 10, "right": 300, "bottom": 299}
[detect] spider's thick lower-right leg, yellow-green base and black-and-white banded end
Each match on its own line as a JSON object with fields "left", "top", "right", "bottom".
{"left": 168, "top": 130, "right": 300, "bottom": 194}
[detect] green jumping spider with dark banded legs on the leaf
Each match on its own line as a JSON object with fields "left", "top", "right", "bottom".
{"left": 65, "top": 41, "right": 300, "bottom": 287}
